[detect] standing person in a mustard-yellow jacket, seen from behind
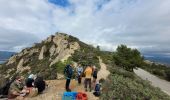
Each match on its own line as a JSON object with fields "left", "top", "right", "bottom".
{"left": 84, "top": 66, "right": 92, "bottom": 92}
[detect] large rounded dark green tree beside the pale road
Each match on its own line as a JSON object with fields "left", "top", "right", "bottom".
{"left": 113, "top": 45, "right": 143, "bottom": 72}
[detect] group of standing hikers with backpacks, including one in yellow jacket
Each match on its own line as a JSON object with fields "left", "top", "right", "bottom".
{"left": 64, "top": 64, "right": 100, "bottom": 96}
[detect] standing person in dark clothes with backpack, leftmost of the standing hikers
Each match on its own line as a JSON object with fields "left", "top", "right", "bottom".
{"left": 64, "top": 64, "right": 73, "bottom": 92}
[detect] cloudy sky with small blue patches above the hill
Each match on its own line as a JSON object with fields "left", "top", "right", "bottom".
{"left": 0, "top": 0, "right": 170, "bottom": 57}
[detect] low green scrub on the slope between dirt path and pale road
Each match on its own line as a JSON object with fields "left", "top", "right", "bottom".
{"left": 100, "top": 69, "right": 170, "bottom": 100}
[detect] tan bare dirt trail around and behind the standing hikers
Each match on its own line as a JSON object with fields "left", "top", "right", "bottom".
{"left": 26, "top": 57, "right": 110, "bottom": 100}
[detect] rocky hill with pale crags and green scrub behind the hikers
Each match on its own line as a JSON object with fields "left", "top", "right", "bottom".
{"left": 0, "top": 33, "right": 98, "bottom": 79}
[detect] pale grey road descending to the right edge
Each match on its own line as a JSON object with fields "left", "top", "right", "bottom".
{"left": 134, "top": 68, "right": 170, "bottom": 95}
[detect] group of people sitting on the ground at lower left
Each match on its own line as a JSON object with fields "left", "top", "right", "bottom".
{"left": 1, "top": 74, "right": 46, "bottom": 100}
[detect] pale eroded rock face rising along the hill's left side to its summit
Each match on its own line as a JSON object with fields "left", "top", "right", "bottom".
{"left": 1, "top": 33, "right": 80, "bottom": 79}
